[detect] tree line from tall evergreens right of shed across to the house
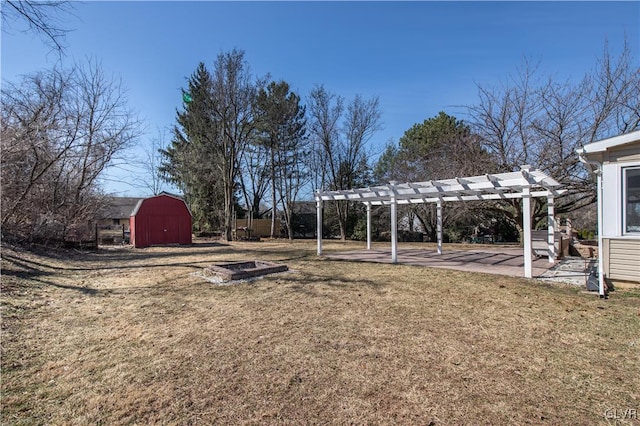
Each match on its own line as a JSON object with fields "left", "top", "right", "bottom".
{"left": 161, "top": 44, "right": 640, "bottom": 243}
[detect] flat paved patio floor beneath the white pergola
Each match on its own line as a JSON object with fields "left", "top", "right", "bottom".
{"left": 324, "top": 247, "right": 593, "bottom": 286}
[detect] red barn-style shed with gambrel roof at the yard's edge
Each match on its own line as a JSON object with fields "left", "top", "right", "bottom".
{"left": 129, "top": 193, "right": 191, "bottom": 247}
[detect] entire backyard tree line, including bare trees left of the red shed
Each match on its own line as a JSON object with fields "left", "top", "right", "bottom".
{"left": 1, "top": 40, "right": 640, "bottom": 245}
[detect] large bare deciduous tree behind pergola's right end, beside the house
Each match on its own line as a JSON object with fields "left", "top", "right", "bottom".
{"left": 468, "top": 40, "right": 640, "bottom": 233}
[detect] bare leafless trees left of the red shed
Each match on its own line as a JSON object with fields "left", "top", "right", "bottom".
{"left": 1, "top": 62, "right": 139, "bottom": 243}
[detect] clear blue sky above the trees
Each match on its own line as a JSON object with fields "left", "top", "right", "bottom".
{"left": 1, "top": 1, "right": 640, "bottom": 196}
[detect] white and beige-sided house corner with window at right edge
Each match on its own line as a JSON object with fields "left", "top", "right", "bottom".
{"left": 577, "top": 131, "right": 640, "bottom": 297}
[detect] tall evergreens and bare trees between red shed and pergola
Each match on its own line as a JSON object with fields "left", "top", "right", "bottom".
{"left": 160, "top": 49, "right": 381, "bottom": 239}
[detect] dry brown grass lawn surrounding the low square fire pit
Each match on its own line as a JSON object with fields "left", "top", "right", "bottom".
{"left": 2, "top": 241, "right": 640, "bottom": 425}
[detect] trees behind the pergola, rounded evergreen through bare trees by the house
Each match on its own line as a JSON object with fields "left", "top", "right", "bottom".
{"left": 375, "top": 43, "right": 640, "bottom": 243}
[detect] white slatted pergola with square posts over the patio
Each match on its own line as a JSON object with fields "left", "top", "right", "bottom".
{"left": 315, "top": 166, "right": 565, "bottom": 278}
